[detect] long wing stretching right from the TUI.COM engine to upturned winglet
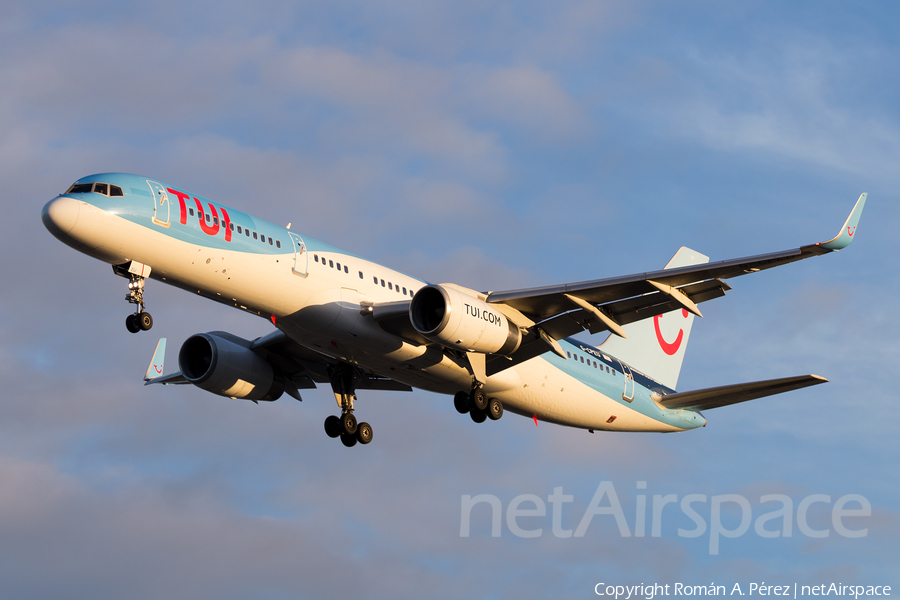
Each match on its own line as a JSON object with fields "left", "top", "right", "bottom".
{"left": 487, "top": 194, "right": 866, "bottom": 339}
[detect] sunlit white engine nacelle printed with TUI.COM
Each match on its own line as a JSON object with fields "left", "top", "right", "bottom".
{"left": 409, "top": 284, "right": 522, "bottom": 356}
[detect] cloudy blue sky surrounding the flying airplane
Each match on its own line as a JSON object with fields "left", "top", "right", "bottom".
{"left": 0, "top": 0, "right": 900, "bottom": 599}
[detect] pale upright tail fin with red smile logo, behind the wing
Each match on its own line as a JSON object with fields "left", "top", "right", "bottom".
{"left": 600, "top": 246, "right": 709, "bottom": 389}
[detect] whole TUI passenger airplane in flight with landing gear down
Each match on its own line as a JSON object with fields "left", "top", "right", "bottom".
{"left": 41, "top": 173, "right": 867, "bottom": 447}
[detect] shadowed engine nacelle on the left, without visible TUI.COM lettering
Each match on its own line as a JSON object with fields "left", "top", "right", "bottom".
{"left": 178, "top": 332, "right": 284, "bottom": 400}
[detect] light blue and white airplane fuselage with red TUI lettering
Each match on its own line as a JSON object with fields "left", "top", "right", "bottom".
{"left": 42, "top": 174, "right": 706, "bottom": 432}
